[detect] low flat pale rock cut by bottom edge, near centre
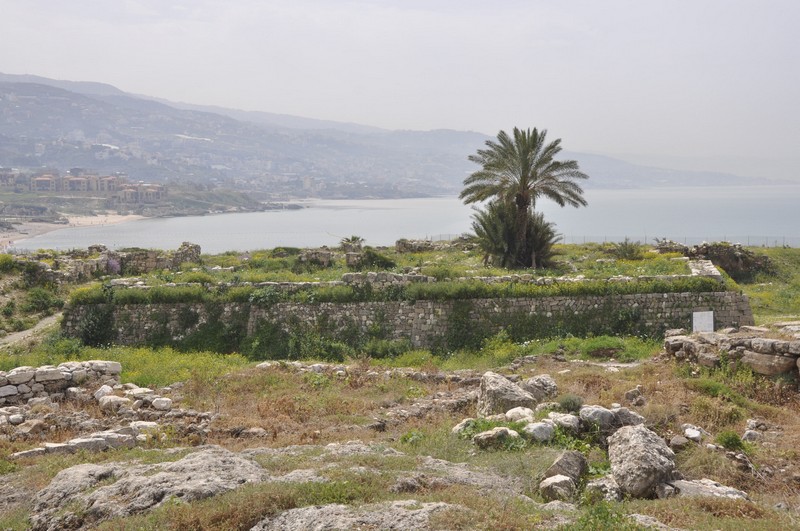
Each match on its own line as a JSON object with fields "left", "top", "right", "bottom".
{"left": 251, "top": 500, "right": 460, "bottom": 531}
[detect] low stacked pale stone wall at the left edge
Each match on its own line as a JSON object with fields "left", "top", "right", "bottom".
{"left": 0, "top": 360, "right": 122, "bottom": 405}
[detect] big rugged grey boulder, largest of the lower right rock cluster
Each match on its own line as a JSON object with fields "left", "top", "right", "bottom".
{"left": 608, "top": 424, "right": 675, "bottom": 498}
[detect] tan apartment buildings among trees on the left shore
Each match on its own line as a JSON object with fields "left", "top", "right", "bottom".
{"left": 0, "top": 168, "right": 167, "bottom": 204}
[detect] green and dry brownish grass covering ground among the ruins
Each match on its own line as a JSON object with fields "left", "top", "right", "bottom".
{"left": 0, "top": 245, "right": 800, "bottom": 530}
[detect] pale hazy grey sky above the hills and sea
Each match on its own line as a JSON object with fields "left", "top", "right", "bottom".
{"left": 0, "top": 0, "right": 800, "bottom": 181}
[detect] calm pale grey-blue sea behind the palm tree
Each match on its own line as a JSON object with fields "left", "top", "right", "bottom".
{"left": 16, "top": 186, "right": 800, "bottom": 253}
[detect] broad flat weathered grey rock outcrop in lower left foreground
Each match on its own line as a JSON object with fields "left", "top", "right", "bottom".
{"left": 31, "top": 447, "right": 268, "bottom": 531}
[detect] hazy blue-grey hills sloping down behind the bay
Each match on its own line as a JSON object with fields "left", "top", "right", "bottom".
{"left": 0, "top": 74, "right": 780, "bottom": 199}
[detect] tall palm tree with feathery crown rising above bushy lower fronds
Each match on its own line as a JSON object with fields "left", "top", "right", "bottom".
{"left": 459, "top": 127, "right": 589, "bottom": 264}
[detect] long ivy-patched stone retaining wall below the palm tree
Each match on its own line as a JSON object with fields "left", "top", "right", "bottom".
{"left": 62, "top": 292, "right": 753, "bottom": 348}
